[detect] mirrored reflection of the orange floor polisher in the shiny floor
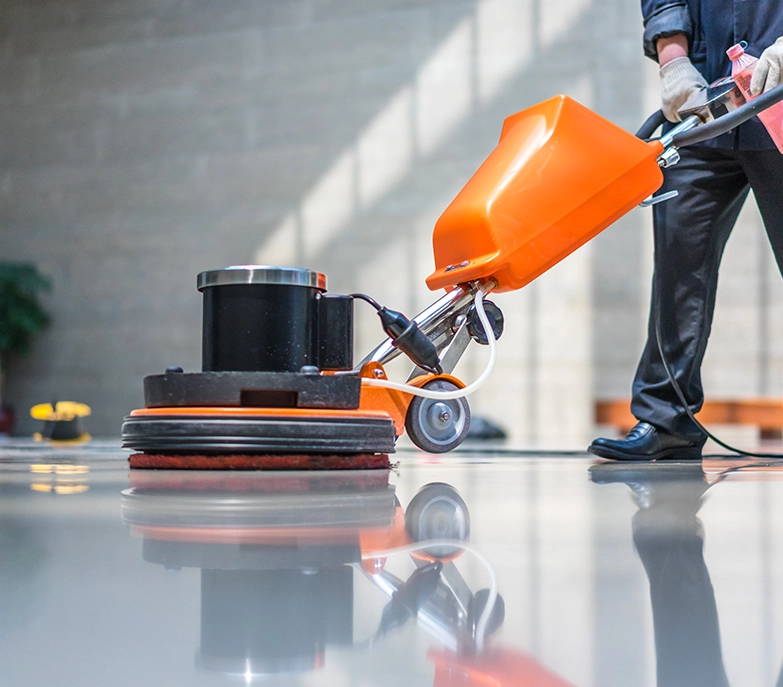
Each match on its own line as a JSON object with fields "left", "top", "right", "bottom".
{"left": 122, "top": 471, "right": 568, "bottom": 687}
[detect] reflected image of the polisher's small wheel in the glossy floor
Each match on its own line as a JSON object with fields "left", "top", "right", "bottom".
{"left": 405, "top": 482, "right": 470, "bottom": 560}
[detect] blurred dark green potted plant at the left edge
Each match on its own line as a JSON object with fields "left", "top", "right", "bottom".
{"left": 0, "top": 262, "right": 52, "bottom": 434}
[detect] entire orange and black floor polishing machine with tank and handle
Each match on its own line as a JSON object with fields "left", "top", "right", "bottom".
{"left": 122, "top": 79, "right": 783, "bottom": 469}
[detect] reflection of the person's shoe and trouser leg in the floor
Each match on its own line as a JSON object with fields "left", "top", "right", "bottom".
{"left": 590, "top": 462, "right": 729, "bottom": 687}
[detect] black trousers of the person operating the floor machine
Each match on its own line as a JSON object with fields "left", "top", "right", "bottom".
{"left": 631, "top": 146, "right": 783, "bottom": 439}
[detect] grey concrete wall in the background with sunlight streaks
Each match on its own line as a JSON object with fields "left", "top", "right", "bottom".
{"left": 0, "top": 0, "right": 783, "bottom": 446}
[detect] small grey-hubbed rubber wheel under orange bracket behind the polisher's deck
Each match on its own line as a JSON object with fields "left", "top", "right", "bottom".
{"left": 405, "top": 379, "right": 470, "bottom": 453}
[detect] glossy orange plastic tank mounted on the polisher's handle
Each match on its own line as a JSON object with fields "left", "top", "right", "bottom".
{"left": 427, "top": 95, "right": 663, "bottom": 291}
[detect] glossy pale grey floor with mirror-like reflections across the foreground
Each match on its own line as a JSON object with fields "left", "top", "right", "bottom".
{"left": 0, "top": 445, "right": 783, "bottom": 687}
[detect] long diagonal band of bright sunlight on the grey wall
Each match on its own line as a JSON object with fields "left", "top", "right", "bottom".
{"left": 254, "top": 0, "right": 544, "bottom": 265}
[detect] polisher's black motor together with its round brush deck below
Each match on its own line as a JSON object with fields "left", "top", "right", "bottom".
{"left": 122, "top": 265, "right": 397, "bottom": 456}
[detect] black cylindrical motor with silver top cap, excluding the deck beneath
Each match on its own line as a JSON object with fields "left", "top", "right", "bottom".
{"left": 198, "top": 265, "right": 353, "bottom": 372}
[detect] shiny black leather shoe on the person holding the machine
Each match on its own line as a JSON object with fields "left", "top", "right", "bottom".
{"left": 587, "top": 422, "right": 704, "bottom": 460}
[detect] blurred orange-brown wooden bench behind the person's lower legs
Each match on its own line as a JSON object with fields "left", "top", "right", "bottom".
{"left": 595, "top": 398, "right": 783, "bottom": 439}
